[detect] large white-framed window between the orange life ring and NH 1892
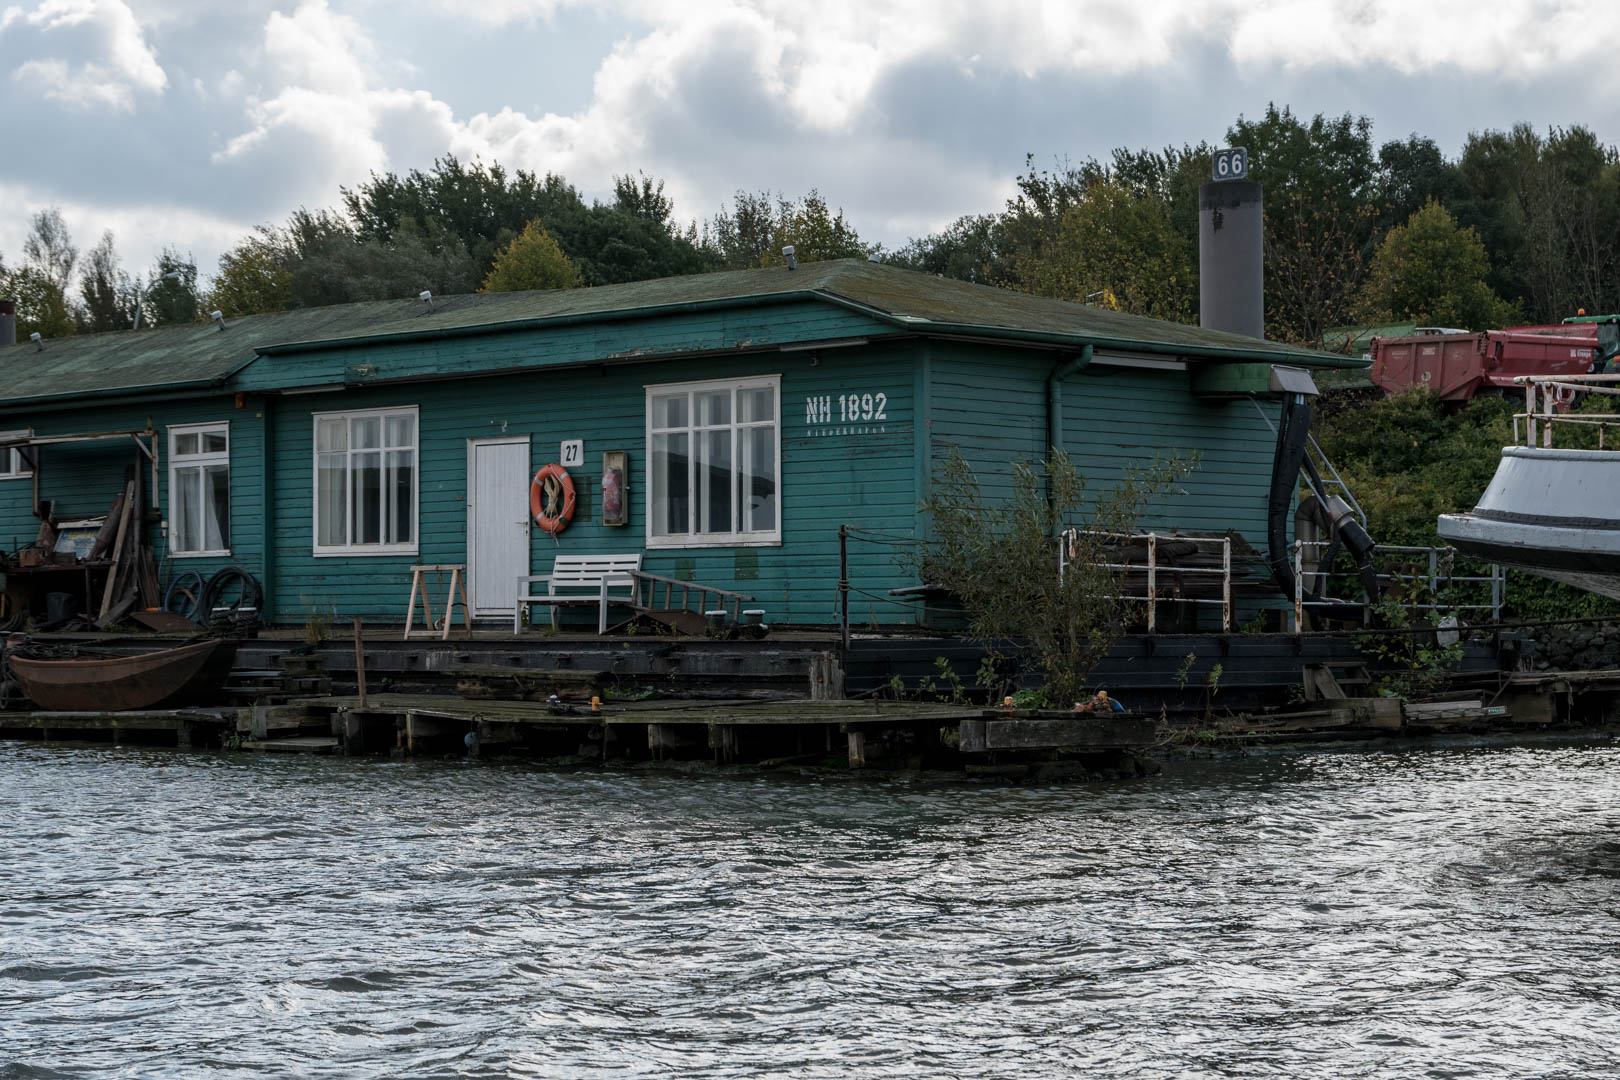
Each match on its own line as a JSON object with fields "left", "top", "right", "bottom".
{"left": 646, "top": 376, "right": 782, "bottom": 547}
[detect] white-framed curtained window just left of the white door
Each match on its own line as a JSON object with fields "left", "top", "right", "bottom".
{"left": 314, "top": 406, "right": 416, "bottom": 555}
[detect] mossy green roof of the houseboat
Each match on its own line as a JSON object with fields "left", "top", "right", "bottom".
{"left": 0, "top": 259, "right": 1362, "bottom": 402}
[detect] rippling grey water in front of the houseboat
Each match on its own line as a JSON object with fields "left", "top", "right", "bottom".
{"left": 0, "top": 743, "right": 1620, "bottom": 1078}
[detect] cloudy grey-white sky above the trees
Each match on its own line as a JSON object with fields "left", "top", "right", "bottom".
{"left": 0, "top": 0, "right": 1620, "bottom": 286}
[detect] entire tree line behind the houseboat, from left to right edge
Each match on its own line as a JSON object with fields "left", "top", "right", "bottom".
{"left": 12, "top": 105, "right": 1620, "bottom": 343}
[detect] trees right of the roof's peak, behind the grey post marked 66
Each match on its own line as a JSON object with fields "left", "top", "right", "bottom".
{"left": 891, "top": 105, "right": 1620, "bottom": 343}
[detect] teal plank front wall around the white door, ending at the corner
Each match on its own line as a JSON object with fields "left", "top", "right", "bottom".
{"left": 272, "top": 345, "right": 915, "bottom": 625}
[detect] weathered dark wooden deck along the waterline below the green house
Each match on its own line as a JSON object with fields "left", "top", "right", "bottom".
{"left": 0, "top": 653, "right": 1620, "bottom": 772}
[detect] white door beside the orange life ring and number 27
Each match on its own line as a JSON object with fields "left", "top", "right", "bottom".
{"left": 467, "top": 436, "right": 530, "bottom": 619}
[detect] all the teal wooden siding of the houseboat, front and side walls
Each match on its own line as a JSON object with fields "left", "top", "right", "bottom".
{"left": 0, "top": 303, "right": 1302, "bottom": 627}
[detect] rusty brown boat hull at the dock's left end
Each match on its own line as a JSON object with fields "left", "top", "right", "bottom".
{"left": 10, "top": 641, "right": 237, "bottom": 712}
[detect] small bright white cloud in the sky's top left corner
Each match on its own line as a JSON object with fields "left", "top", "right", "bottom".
{"left": 0, "top": 0, "right": 168, "bottom": 112}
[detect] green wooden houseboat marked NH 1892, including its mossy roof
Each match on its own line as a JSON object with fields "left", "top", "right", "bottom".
{"left": 0, "top": 261, "right": 1359, "bottom": 627}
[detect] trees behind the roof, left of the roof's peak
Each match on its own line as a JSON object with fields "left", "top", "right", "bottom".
{"left": 0, "top": 166, "right": 876, "bottom": 337}
